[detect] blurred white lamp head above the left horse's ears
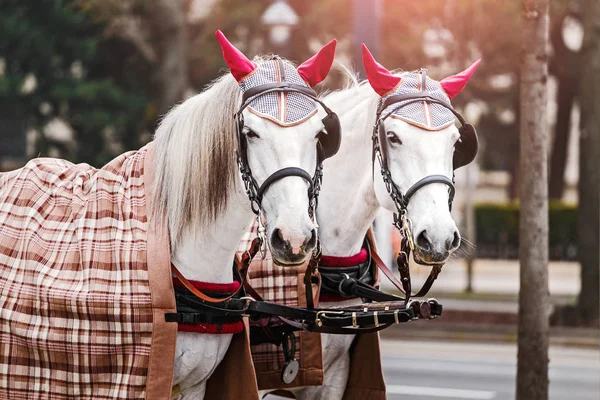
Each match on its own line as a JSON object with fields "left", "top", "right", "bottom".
{"left": 260, "top": 0, "right": 299, "bottom": 55}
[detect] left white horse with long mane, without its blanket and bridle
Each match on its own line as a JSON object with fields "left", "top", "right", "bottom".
{"left": 153, "top": 32, "right": 335, "bottom": 399}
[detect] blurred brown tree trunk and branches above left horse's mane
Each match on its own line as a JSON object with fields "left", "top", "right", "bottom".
{"left": 76, "top": 0, "right": 191, "bottom": 115}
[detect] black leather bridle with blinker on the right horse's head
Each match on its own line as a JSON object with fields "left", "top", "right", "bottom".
{"left": 372, "top": 86, "right": 478, "bottom": 303}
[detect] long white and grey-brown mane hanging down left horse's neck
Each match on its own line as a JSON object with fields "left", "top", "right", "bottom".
{"left": 153, "top": 73, "right": 242, "bottom": 245}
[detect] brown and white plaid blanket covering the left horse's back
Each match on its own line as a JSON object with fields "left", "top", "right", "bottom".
{"left": 0, "top": 145, "right": 177, "bottom": 399}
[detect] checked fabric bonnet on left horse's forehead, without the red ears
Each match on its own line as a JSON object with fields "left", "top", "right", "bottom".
{"left": 239, "top": 60, "right": 317, "bottom": 126}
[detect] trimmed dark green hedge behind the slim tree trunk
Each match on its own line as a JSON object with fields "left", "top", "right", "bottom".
{"left": 475, "top": 201, "right": 577, "bottom": 260}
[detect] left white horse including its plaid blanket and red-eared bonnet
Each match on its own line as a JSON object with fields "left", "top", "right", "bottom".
{"left": 0, "top": 32, "right": 336, "bottom": 400}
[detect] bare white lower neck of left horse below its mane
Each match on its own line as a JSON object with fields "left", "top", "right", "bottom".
{"left": 171, "top": 190, "right": 253, "bottom": 283}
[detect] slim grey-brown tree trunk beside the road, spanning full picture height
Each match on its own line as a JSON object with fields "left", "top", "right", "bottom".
{"left": 516, "top": 0, "right": 549, "bottom": 400}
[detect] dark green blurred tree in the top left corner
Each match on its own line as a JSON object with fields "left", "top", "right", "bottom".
{"left": 0, "top": 0, "right": 147, "bottom": 165}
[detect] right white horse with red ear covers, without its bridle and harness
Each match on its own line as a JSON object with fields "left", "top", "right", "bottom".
{"left": 284, "top": 48, "right": 476, "bottom": 400}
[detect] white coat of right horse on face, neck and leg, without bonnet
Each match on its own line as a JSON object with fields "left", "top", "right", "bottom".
{"left": 293, "top": 76, "right": 458, "bottom": 400}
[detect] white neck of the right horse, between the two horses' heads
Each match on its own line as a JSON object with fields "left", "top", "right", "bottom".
{"left": 317, "top": 116, "right": 379, "bottom": 257}
